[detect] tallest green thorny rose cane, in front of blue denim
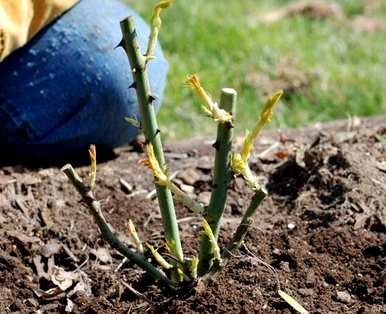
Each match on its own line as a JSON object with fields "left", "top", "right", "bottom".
{"left": 121, "top": 17, "right": 184, "bottom": 261}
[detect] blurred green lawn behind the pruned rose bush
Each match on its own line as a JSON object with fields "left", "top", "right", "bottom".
{"left": 126, "top": 0, "right": 386, "bottom": 138}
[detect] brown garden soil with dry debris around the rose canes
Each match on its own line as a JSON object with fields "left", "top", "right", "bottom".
{"left": 0, "top": 117, "right": 386, "bottom": 314}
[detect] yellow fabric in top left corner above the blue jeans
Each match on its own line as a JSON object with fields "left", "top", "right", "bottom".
{"left": 0, "top": 0, "right": 79, "bottom": 62}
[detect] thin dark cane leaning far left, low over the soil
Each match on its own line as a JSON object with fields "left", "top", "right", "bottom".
{"left": 62, "top": 165, "right": 175, "bottom": 289}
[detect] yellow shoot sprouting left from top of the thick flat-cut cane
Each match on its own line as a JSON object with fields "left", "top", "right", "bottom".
{"left": 185, "top": 74, "right": 232, "bottom": 123}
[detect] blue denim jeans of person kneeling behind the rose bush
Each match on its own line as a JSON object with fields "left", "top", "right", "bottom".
{"left": 0, "top": 0, "right": 168, "bottom": 158}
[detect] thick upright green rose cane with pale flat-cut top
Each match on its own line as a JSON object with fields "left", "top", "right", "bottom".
{"left": 197, "top": 88, "right": 237, "bottom": 276}
